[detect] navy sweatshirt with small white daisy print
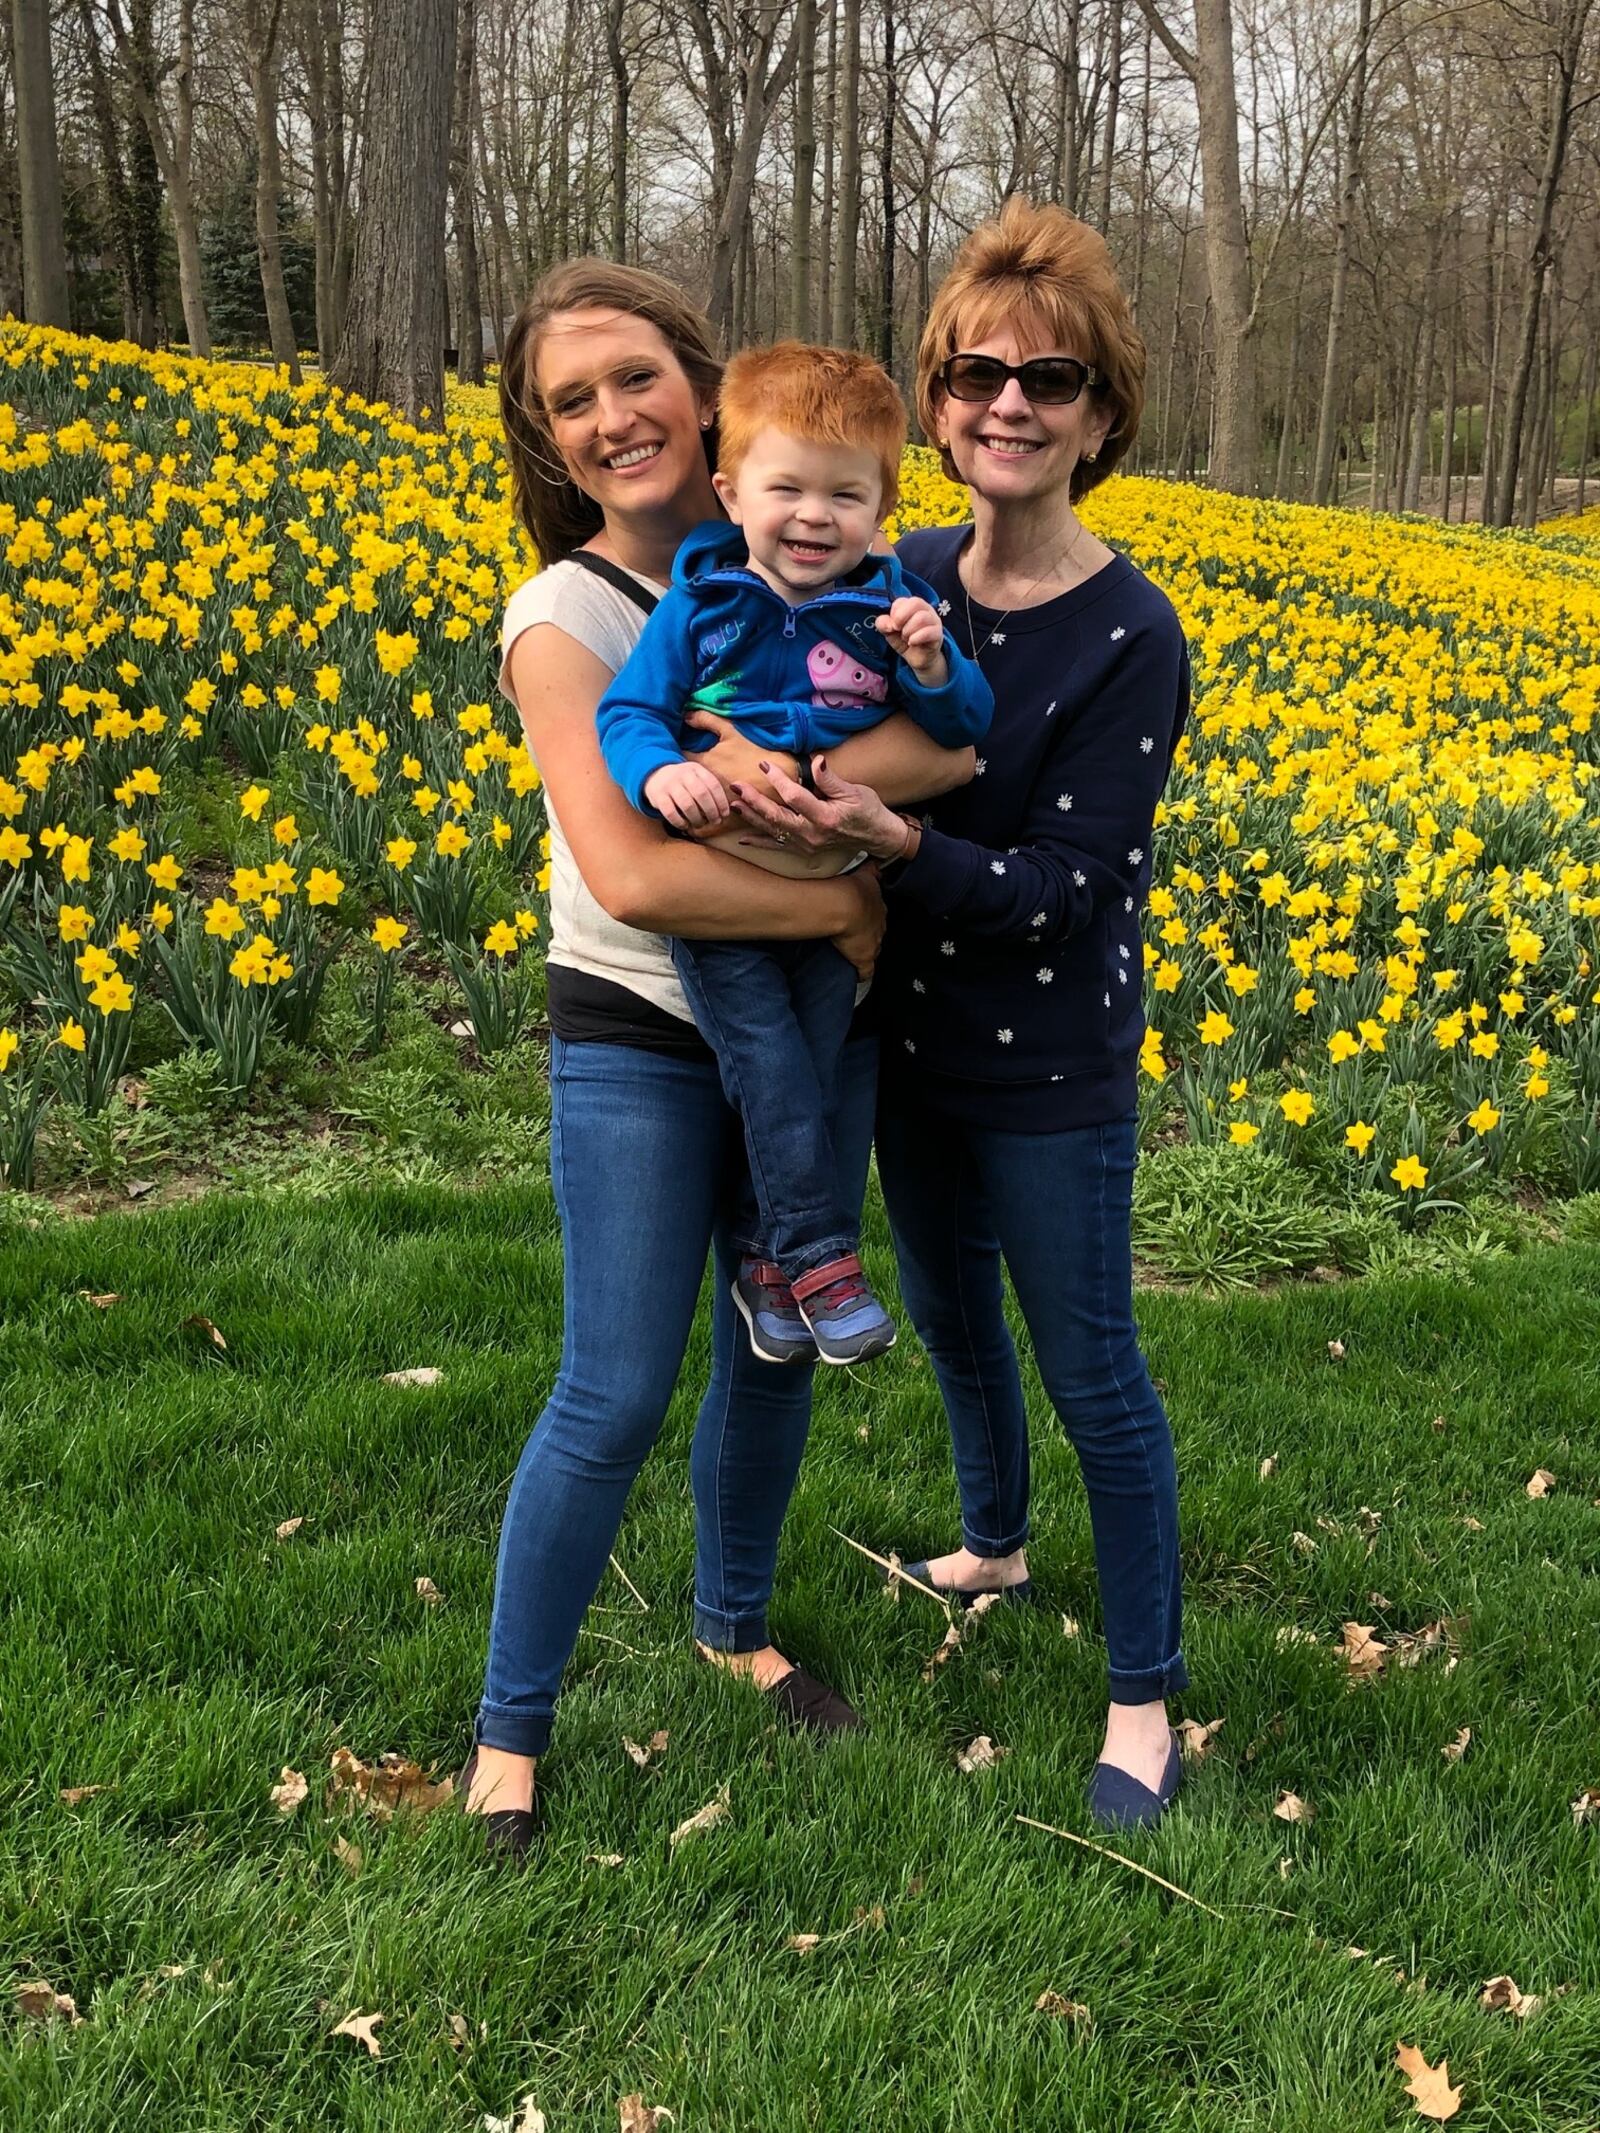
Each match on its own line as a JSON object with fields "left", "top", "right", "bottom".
{"left": 873, "top": 525, "right": 1188, "bottom": 1133}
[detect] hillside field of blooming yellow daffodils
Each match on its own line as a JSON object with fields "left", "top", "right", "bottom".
{"left": 0, "top": 324, "right": 1600, "bottom": 1220}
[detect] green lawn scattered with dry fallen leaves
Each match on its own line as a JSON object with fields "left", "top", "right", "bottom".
{"left": 0, "top": 1186, "right": 1600, "bottom": 2133}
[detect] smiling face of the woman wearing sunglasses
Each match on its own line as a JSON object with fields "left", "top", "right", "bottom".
{"left": 937, "top": 320, "right": 1114, "bottom": 503}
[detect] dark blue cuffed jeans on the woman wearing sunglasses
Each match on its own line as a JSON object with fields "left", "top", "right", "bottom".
{"left": 877, "top": 1092, "right": 1188, "bottom": 1704}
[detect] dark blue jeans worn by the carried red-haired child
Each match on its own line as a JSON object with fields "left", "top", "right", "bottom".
{"left": 672, "top": 941, "right": 860, "bottom": 1282}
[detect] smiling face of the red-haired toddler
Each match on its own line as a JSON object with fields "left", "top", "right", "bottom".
{"left": 715, "top": 429, "right": 883, "bottom": 602}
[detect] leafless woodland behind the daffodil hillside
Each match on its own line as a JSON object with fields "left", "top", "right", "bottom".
{"left": 0, "top": 0, "right": 1600, "bottom": 525}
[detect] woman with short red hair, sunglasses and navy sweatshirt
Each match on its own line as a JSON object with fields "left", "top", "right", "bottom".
{"left": 733, "top": 201, "right": 1188, "bottom": 1826}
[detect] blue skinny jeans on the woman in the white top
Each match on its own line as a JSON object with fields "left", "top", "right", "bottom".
{"left": 478, "top": 1037, "right": 877, "bottom": 1755}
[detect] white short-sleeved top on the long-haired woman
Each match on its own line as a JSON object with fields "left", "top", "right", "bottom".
{"left": 499, "top": 563, "right": 693, "bottom": 1022}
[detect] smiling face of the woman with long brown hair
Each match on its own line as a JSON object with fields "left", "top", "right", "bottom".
{"left": 533, "top": 307, "right": 713, "bottom": 516}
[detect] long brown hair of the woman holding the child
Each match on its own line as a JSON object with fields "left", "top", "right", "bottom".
{"left": 499, "top": 260, "right": 721, "bottom": 570}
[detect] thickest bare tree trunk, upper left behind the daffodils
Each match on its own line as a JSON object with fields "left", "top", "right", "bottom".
{"left": 333, "top": 0, "right": 454, "bottom": 427}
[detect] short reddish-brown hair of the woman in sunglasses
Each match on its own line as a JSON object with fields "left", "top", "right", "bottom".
{"left": 917, "top": 194, "right": 1146, "bottom": 501}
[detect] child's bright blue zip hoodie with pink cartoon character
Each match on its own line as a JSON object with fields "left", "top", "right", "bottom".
{"left": 599, "top": 518, "right": 994, "bottom": 813}
